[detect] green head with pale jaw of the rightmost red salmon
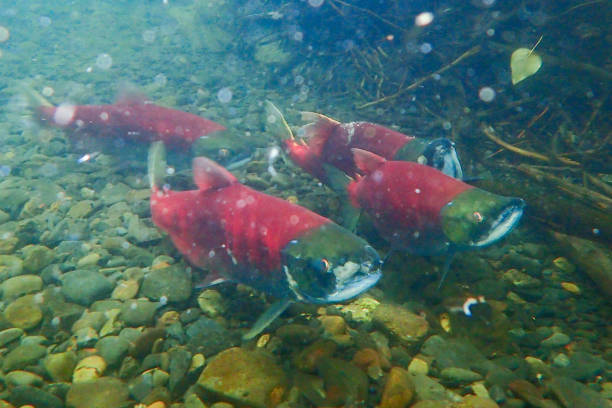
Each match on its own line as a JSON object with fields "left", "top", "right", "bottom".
{"left": 440, "top": 188, "right": 525, "bottom": 248}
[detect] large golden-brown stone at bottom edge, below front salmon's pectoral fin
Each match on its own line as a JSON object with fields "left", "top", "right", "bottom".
{"left": 197, "top": 347, "right": 287, "bottom": 408}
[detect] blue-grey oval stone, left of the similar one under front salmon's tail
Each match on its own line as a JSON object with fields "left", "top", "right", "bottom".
{"left": 62, "top": 269, "right": 113, "bottom": 306}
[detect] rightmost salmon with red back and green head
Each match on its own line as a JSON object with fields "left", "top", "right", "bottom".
{"left": 348, "top": 149, "right": 524, "bottom": 255}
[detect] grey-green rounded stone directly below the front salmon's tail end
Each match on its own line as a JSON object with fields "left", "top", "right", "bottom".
{"left": 140, "top": 265, "right": 192, "bottom": 302}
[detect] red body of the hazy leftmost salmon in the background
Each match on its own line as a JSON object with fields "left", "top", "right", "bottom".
{"left": 38, "top": 100, "right": 225, "bottom": 148}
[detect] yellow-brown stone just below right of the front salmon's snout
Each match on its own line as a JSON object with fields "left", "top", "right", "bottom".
{"left": 373, "top": 303, "right": 429, "bottom": 345}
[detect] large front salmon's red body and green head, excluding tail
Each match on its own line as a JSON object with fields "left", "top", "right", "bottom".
{"left": 151, "top": 146, "right": 380, "bottom": 303}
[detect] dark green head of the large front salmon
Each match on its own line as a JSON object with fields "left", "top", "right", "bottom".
{"left": 281, "top": 223, "right": 382, "bottom": 303}
